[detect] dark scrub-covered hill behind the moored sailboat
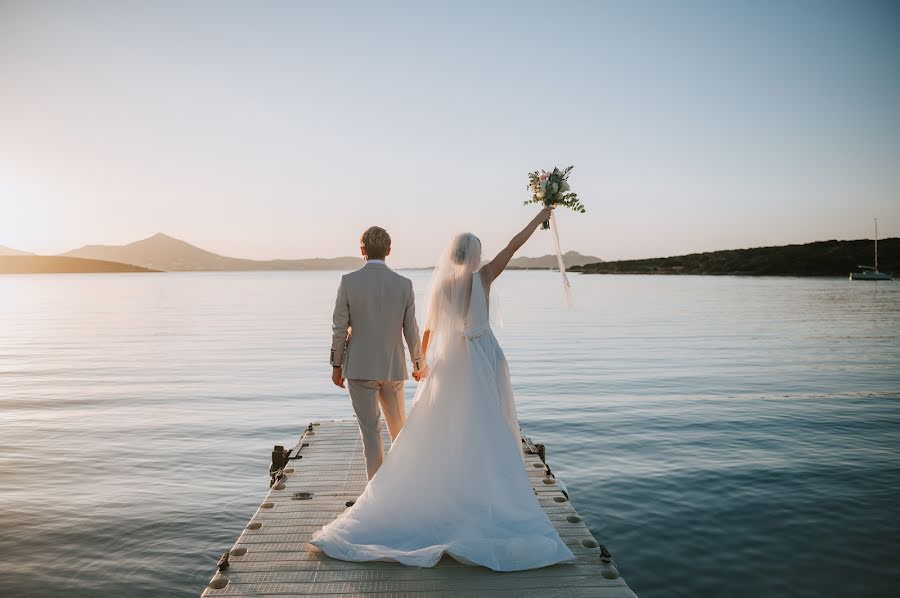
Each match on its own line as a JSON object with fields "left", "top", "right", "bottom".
{"left": 572, "top": 238, "right": 900, "bottom": 276}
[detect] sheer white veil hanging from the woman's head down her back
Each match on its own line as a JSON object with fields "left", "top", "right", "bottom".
{"left": 425, "top": 233, "right": 481, "bottom": 359}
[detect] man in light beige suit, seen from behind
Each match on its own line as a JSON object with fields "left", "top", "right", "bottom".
{"left": 331, "top": 226, "right": 426, "bottom": 480}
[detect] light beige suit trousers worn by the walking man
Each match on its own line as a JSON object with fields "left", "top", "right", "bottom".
{"left": 347, "top": 380, "right": 406, "bottom": 480}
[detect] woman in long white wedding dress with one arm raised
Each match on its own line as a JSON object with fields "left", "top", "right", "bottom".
{"left": 310, "top": 208, "right": 575, "bottom": 571}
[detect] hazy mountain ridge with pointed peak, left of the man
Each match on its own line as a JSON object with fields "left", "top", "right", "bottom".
{"left": 64, "top": 233, "right": 363, "bottom": 271}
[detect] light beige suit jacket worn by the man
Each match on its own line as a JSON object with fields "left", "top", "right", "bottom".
{"left": 331, "top": 262, "right": 423, "bottom": 380}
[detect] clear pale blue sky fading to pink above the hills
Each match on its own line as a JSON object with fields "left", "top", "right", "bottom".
{"left": 0, "top": 0, "right": 900, "bottom": 265}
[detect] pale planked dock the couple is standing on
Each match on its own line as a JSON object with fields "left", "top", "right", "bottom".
{"left": 202, "top": 420, "right": 635, "bottom": 598}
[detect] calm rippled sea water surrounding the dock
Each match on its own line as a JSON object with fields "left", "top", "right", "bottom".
{"left": 0, "top": 271, "right": 900, "bottom": 598}
